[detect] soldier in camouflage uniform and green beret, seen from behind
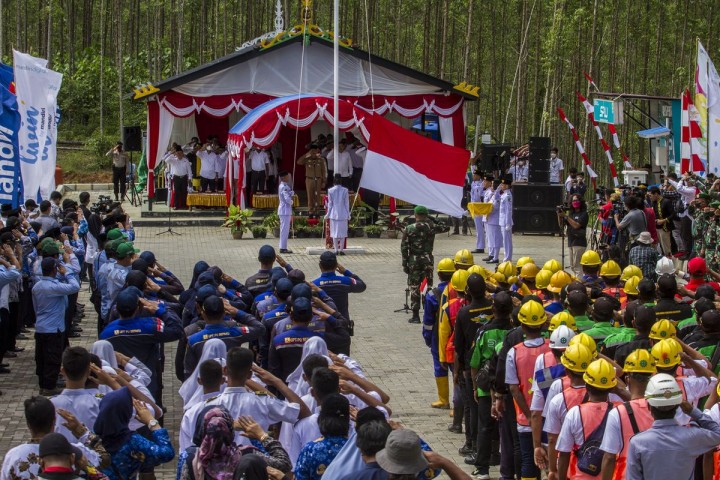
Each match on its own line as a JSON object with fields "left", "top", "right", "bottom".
{"left": 400, "top": 205, "right": 437, "bottom": 323}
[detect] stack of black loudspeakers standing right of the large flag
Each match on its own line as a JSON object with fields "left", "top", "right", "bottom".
{"left": 512, "top": 137, "right": 564, "bottom": 235}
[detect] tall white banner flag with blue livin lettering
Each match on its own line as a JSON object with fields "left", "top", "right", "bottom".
{"left": 13, "top": 50, "right": 62, "bottom": 200}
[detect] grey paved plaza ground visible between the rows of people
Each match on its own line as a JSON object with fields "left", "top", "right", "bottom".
{"left": 0, "top": 223, "right": 567, "bottom": 480}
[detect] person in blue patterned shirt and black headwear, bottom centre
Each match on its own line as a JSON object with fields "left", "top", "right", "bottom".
{"left": 295, "top": 393, "right": 350, "bottom": 480}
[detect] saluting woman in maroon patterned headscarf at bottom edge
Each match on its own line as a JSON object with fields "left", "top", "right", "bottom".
{"left": 178, "top": 406, "right": 292, "bottom": 480}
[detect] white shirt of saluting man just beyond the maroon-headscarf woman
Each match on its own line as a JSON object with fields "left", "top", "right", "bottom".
{"left": 208, "top": 387, "right": 300, "bottom": 445}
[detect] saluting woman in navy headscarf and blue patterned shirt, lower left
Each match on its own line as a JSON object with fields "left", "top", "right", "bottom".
{"left": 93, "top": 387, "right": 175, "bottom": 480}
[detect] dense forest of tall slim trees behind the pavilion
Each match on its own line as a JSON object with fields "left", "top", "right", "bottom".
{"left": 0, "top": 0, "right": 720, "bottom": 183}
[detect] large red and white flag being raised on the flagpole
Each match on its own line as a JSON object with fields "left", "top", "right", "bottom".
{"left": 360, "top": 115, "right": 470, "bottom": 217}
